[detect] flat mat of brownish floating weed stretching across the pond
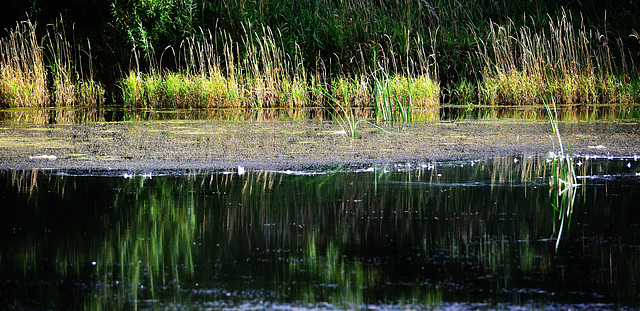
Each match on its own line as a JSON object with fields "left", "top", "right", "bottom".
{"left": 0, "top": 119, "right": 640, "bottom": 171}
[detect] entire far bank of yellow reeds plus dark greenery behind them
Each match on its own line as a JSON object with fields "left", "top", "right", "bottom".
{"left": 0, "top": 0, "right": 640, "bottom": 108}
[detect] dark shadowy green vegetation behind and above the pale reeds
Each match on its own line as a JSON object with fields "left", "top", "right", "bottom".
{"left": 0, "top": 0, "right": 640, "bottom": 102}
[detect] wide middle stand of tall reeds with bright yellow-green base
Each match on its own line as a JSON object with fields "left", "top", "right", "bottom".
{"left": 120, "top": 27, "right": 439, "bottom": 120}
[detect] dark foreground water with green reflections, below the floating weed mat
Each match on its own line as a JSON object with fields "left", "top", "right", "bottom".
{"left": 0, "top": 156, "right": 640, "bottom": 310}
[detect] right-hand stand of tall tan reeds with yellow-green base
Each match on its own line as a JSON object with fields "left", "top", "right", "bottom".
{"left": 477, "top": 11, "right": 635, "bottom": 104}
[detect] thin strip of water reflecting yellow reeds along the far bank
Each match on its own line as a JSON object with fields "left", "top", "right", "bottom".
{"left": 0, "top": 105, "right": 640, "bottom": 125}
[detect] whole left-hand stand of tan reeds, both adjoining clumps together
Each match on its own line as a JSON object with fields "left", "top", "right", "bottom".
{"left": 0, "top": 20, "right": 105, "bottom": 107}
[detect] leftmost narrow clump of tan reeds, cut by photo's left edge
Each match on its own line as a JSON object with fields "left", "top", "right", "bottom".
{"left": 0, "top": 21, "right": 49, "bottom": 107}
